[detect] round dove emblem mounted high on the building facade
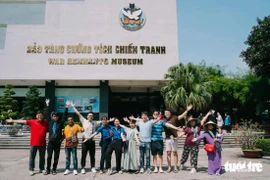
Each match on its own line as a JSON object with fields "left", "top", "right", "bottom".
{"left": 120, "top": 4, "right": 146, "bottom": 31}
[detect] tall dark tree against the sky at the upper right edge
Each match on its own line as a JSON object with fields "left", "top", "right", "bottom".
{"left": 240, "top": 15, "right": 270, "bottom": 77}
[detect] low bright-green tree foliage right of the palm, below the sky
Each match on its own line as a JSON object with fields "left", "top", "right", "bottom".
{"left": 210, "top": 68, "right": 270, "bottom": 118}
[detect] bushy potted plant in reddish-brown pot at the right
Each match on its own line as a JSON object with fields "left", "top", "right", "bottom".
{"left": 233, "top": 120, "right": 264, "bottom": 158}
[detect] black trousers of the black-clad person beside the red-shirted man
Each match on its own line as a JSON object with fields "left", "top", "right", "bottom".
{"left": 47, "top": 142, "right": 62, "bottom": 172}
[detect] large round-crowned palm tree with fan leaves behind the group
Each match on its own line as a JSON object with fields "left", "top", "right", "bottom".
{"left": 161, "top": 63, "right": 212, "bottom": 112}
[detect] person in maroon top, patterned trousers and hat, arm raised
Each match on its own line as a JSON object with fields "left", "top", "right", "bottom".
{"left": 178, "top": 112, "right": 211, "bottom": 173}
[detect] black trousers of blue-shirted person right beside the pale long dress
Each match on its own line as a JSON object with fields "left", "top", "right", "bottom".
{"left": 105, "top": 139, "right": 123, "bottom": 171}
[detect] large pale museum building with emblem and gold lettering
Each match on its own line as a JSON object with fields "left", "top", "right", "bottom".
{"left": 0, "top": 0, "right": 179, "bottom": 118}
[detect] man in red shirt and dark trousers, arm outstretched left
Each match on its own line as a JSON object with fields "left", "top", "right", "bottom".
{"left": 6, "top": 111, "right": 48, "bottom": 176}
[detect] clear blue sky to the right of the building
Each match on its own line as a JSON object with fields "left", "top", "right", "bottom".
{"left": 177, "top": 0, "right": 270, "bottom": 73}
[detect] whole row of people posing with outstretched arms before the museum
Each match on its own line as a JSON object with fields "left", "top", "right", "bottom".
{"left": 6, "top": 99, "right": 226, "bottom": 175}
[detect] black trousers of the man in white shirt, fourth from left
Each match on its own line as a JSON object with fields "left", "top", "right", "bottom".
{"left": 81, "top": 139, "right": 96, "bottom": 168}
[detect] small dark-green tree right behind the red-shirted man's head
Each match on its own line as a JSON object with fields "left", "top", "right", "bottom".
{"left": 22, "top": 86, "right": 41, "bottom": 119}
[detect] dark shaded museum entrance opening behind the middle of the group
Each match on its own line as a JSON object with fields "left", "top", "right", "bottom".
{"left": 109, "top": 93, "right": 164, "bottom": 119}
